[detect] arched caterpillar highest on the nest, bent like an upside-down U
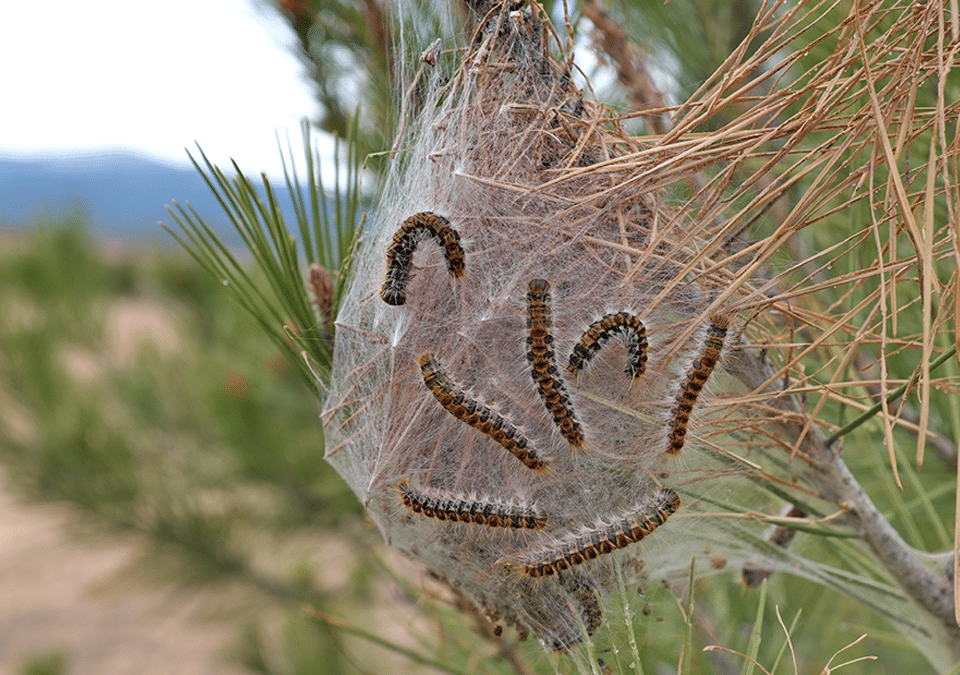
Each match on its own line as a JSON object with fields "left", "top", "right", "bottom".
{"left": 380, "top": 211, "right": 464, "bottom": 305}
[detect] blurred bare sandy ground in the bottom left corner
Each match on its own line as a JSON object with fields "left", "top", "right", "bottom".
{"left": 0, "top": 479, "right": 244, "bottom": 675}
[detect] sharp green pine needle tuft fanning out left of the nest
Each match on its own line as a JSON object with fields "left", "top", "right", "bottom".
{"left": 161, "top": 117, "right": 363, "bottom": 393}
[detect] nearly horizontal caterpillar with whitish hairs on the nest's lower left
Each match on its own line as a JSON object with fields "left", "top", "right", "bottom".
{"left": 398, "top": 478, "right": 547, "bottom": 530}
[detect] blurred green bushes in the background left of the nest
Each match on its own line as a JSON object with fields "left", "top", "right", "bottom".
{"left": 0, "top": 216, "right": 376, "bottom": 674}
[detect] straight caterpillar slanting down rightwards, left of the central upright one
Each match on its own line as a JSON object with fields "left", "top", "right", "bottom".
{"left": 417, "top": 352, "right": 547, "bottom": 471}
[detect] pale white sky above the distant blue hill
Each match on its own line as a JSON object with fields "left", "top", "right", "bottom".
{"left": 0, "top": 0, "right": 317, "bottom": 174}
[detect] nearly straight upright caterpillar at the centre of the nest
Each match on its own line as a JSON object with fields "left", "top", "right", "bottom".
{"left": 527, "top": 279, "right": 583, "bottom": 448}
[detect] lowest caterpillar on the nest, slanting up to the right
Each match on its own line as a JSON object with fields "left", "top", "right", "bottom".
{"left": 521, "top": 488, "right": 680, "bottom": 579}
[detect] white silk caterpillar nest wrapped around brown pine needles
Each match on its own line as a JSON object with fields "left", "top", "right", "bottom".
{"left": 324, "top": 3, "right": 737, "bottom": 650}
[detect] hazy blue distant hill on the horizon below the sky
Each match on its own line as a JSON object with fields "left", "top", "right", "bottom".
{"left": 0, "top": 153, "right": 306, "bottom": 245}
